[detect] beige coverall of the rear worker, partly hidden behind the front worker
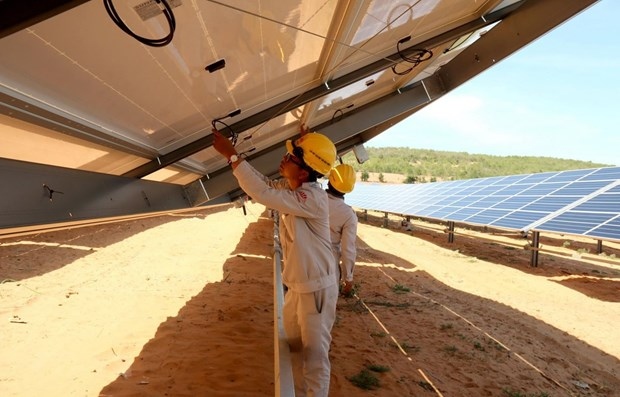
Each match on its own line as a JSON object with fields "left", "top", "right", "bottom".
{"left": 327, "top": 193, "right": 357, "bottom": 282}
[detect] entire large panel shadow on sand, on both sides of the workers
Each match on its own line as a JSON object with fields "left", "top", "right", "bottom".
{"left": 94, "top": 209, "right": 620, "bottom": 397}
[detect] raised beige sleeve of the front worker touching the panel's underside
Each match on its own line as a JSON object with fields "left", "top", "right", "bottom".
{"left": 233, "top": 161, "right": 321, "bottom": 218}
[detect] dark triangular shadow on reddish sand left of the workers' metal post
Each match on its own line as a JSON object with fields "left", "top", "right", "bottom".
{"left": 100, "top": 209, "right": 274, "bottom": 397}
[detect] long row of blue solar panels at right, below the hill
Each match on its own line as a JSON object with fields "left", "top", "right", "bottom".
{"left": 345, "top": 167, "right": 620, "bottom": 240}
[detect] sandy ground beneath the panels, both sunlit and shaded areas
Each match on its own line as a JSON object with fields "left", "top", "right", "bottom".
{"left": 0, "top": 203, "right": 620, "bottom": 397}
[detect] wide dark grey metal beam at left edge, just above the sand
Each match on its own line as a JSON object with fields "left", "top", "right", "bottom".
{"left": 0, "top": 159, "right": 190, "bottom": 234}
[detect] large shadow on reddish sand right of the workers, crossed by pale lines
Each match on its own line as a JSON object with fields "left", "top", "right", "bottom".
{"left": 330, "top": 235, "right": 620, "bottom": 397}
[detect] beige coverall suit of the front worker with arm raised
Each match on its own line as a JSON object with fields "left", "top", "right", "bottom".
{"left": 233, "top": 161, "right": 338, "bottom": 397}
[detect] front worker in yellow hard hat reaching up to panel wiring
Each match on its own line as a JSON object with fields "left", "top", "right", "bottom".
{"left": 213, "top": 130, "right": 338, "bottom": 397}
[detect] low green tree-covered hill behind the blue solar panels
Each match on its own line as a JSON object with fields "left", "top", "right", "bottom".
{"left": 343, "top": 147, "right": 609, "bottom": 183}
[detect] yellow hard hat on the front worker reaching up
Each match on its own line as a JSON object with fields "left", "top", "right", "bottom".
{"left": 286, "top": 132, "right": 337, "bottom": 175}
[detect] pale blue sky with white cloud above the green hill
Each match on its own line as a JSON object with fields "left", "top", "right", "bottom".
{"left": 366, "top": 0, "right": 620, "bottom": 166}
